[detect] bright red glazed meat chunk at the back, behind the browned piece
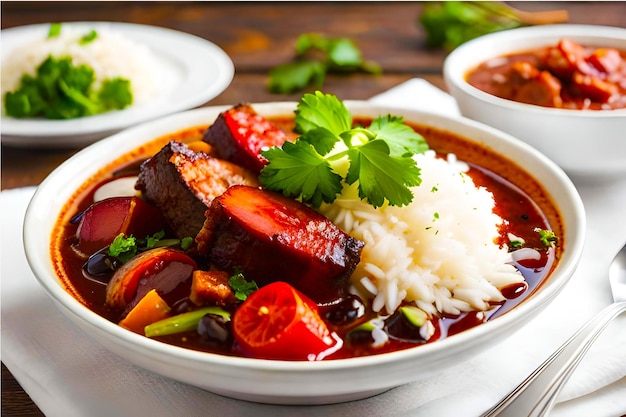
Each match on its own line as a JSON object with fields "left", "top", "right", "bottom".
{"left": 203, "top": 104, "right": 288, "bottom": 173}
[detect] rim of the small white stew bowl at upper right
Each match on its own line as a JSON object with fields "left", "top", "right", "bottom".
{"left": 443, "top": 24, "right": 626, "bottom": 119}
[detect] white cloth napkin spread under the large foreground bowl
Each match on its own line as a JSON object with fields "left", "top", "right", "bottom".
{"left": 0, "top": 80, "right": 626, "bottom": 417}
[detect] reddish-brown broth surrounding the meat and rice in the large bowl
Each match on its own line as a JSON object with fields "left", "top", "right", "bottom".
{"left": 51, "top": 116, "right": 564, "bottom": 359}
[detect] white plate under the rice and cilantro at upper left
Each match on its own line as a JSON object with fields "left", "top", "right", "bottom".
{"left": 0, "top": 22, "right": 235, "bottom": 148}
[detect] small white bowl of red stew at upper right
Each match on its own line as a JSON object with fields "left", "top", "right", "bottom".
{"left": 444, "top": 24, "right": 626, "bottom": 182}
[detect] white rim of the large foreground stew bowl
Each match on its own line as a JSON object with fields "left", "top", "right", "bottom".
{"left": 24, "top": 101, "right": 586, "bottom": 373}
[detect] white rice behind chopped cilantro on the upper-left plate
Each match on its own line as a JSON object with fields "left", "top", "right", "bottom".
{"left": 2, "top": 25, "right": 157, "bottom": 104}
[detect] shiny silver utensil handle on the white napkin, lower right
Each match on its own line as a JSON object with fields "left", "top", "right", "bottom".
{"left": 481, "top": 302, "right": 626, "bottom": 417}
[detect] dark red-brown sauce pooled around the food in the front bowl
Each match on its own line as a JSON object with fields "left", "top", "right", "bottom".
{"left": 52, "top": 117, "right": 564, "bottom": 359}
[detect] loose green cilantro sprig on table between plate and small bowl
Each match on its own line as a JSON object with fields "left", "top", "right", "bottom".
{"left": 267, "top": 33, "right": 382, "bottom": 94}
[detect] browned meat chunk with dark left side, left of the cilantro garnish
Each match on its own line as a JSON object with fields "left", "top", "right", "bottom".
{"left": 135, "top": 141, "right": 258, "bottom": 238}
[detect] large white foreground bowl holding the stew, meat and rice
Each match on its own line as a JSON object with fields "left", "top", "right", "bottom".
{"left": 24, "top": 102, "right": 585, "bottom": 404}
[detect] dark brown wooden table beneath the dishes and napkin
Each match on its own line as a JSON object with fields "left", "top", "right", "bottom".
{"left": 1, "top": 2, "right": 626, "bottom": 416}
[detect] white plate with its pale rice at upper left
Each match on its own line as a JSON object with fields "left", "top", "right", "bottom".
{"left": 0, "top": 22, "right": 234, "bottom": 148}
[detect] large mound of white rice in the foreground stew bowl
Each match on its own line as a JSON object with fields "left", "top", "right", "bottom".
{"left": 322, "top": 151, "right": 524, "bottom": 315}
